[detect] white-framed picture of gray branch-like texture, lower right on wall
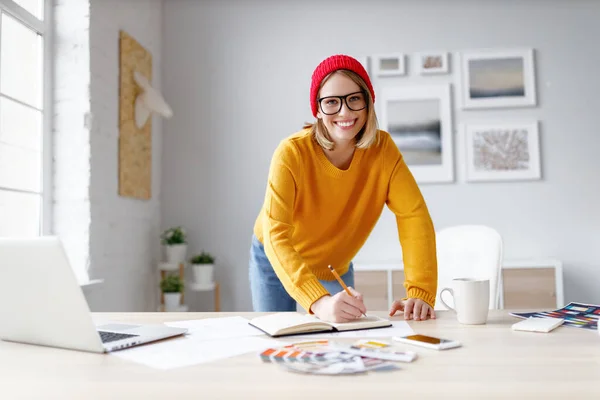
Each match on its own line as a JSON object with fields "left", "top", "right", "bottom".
{"left": 463, "top": 121, "right": 541, "bottom": 181}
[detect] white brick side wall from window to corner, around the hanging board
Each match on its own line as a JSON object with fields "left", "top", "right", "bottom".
{"left": 54, "top": 0, "right": 162, "bottom": 311}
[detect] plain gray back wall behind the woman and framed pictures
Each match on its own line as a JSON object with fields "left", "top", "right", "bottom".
{"left": 161, "top": 0, "right": 600, "bottom": 310}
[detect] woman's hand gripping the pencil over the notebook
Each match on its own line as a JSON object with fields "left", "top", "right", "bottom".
{"left": 310, "top": 287, "right": 367, "bottom": 322}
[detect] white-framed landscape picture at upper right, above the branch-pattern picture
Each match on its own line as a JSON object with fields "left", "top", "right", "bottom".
{"left": 460, "top": 49, "right": 536, "bottom": 108}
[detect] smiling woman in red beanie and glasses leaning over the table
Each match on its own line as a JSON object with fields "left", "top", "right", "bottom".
{"left": 250, "top": 55, "right": 437, "bottom": 322}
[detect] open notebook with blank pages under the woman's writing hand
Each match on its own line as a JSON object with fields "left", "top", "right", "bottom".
{"left": 249, "top": 312, "right": 392, "bottom": 337}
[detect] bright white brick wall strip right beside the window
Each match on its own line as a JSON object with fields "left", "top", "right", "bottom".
{"left": 52, "top": 0, "right": 91, "bottom": 281}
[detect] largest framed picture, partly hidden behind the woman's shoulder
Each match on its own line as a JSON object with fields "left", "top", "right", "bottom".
{"left": 379, "top": 84, "right": 454, "bottom": 183}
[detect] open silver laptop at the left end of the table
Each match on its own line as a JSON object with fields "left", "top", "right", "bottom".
{"left": 0, "top": 236, "right": 187, "bottom": 353}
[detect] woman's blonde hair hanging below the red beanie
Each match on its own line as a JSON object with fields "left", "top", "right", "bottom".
{"left": 303, "top": 70, "right": 379, "bottom": 150}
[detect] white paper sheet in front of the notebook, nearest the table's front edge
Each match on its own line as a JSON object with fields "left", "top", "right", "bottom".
{"left": 111, "top": 336, "right": 285, "bottom": 370}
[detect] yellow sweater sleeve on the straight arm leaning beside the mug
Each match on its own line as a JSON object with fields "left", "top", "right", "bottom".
{"left": 387, "top": 148, "right": 437, "bottom": 307}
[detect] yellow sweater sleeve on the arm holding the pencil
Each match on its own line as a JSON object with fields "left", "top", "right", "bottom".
{"left": 263, "top": 144, "right": 329, "bottom": 313}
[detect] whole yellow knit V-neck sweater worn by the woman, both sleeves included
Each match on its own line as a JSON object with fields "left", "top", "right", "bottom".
{"left": 254, "top": 130, "right": 437, "bottom": 311}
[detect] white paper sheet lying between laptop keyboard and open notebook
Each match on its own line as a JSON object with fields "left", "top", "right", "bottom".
{"left": 165, "top": 317, "right": 264, "bottom": 340}
